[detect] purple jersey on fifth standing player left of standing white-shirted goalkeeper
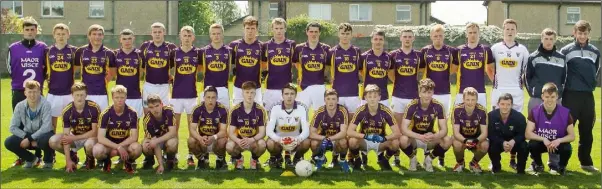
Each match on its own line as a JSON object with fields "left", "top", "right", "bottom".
{"left": 327, "top": 45, "right": 363, "bottom": 97}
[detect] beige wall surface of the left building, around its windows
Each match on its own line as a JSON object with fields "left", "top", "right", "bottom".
{"left": 23, "top": 1, "right": 177, "bottom": 34}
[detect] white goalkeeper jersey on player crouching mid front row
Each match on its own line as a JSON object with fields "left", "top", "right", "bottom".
{"left": 266, "top": 101, "right": 309, "bottom": 142}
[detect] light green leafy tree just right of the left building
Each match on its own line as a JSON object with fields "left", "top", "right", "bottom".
{"left": 178, "top": 1, "right": 214, "bottom": 35}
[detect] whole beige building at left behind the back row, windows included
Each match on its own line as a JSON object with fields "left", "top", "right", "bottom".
{"left": 1, "top": 1, "right": 178, "bottom": 35}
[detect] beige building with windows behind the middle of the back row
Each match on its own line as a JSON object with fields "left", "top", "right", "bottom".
{"left": 225, "top": 0, "right": 441, "bottom": 36}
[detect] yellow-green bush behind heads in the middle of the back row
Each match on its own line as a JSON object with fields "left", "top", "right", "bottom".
{"left": 268, "top": 14, "right": 337, "bottom": 39}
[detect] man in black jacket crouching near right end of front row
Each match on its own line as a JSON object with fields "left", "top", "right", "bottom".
{"left": 487, "top": 93, "right": 529, "bottom": 174}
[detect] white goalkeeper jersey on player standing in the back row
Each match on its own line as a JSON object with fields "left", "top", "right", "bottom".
{"left": 491, "top": 41, "right": 529, "bottom": 90}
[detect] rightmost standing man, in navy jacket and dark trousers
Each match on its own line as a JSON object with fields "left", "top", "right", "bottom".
{"left": 560, "top": 20, "right": 600, "bottom": 172}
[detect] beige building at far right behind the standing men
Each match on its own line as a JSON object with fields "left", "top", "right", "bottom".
{"left": 483, "top": 0, "right": 602, "bottom": 39}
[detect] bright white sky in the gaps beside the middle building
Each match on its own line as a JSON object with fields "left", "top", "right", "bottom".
{"left": 236, "top": 1, "right": 487, "bottom": 25}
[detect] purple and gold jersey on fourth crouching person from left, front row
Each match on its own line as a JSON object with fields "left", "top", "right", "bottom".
{"left": 144, "top": 106, "right": 175, "bottom": 138}
